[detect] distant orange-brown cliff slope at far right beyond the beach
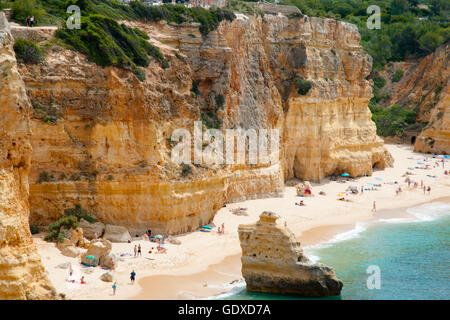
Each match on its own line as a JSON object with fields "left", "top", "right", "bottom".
{"left": 380, "top": 43, "right": 450, "bottom": 154}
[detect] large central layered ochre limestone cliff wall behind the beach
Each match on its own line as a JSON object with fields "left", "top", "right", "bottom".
{"left": 14, "top": 14, "right": 392, "bottom": 234}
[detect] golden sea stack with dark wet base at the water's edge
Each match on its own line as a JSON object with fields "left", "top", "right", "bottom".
{"left": 238, "top": 211, "right": 343, "bottom": 297}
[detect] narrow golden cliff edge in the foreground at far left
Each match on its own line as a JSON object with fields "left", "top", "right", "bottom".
{"left": 0, "top": 12, "right": 55, "bottom": 300}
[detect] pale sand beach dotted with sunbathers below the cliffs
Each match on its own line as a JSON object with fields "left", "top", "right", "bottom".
{"left": 35, "top": 145, "right": 450, "bottom": 299}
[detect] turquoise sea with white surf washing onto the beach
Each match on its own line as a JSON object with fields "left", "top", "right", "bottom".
{"left": 218, "top": 202, "right": 450, "bottom": 300}
